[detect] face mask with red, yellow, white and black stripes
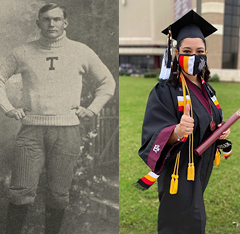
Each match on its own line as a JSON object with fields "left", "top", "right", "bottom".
{"left": 178, "top": 54, "right": 207, "bottom": 76}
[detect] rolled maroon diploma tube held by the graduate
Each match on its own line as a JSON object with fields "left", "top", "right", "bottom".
{"left": 194, "top": 109, "right": 240, "bottom": 156}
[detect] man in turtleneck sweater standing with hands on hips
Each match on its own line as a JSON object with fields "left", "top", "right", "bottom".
{"left": 0, "top": 4, "right": 115, "bottom": 234}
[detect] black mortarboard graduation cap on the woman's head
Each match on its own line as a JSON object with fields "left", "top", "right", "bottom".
{"left": 162, "top": 10, "right": 217, "bottom": 42}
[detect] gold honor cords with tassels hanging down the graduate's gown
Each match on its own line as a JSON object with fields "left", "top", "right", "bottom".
{"left": 169, "top": 74, "right": 195, "bottom": 194}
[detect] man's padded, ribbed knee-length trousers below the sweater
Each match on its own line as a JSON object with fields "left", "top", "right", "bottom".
{"left": 9, "top": 125, "right": 80, "bottom": 209}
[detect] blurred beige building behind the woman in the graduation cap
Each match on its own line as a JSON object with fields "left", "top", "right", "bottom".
{"left": 119, "top": 0, "right": 240, "bottom": 81}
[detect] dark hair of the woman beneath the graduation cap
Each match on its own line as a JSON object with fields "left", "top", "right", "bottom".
{"left": 168, "top": 39, "right": 210, "bottom": 87}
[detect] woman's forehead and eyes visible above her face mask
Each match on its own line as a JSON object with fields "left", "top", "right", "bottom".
{"left": 176, "top": 38, "right": 206, "bottom": 58}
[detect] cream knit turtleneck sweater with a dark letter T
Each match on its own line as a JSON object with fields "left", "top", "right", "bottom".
{"left": 0, "top": 32, "right": 115, "bottom": 126}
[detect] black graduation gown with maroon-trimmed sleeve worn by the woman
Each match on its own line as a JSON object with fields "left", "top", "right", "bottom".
{"left": 139, "top": 80, "right": 222, "bottom": 234}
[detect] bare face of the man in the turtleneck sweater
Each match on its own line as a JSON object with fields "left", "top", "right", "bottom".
{"left": 36, "top": 8, "right": 68, "bottom": 39}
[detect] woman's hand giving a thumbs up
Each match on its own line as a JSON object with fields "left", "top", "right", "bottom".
{"left": 176, "top": 104, "right": 194, "bottom": 137}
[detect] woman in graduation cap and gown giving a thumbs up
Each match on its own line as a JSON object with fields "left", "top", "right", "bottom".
{"left": 139, "top": 11, "right": 230, "bottom": 234}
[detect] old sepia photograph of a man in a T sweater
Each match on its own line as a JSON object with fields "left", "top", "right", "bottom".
{"left": 0, "top": 0, "right": 119, "bottom": 234}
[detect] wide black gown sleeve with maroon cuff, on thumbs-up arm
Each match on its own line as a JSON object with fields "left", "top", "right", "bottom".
{"left": 138, "top": 81, "right": 182, "bottom": 174}
